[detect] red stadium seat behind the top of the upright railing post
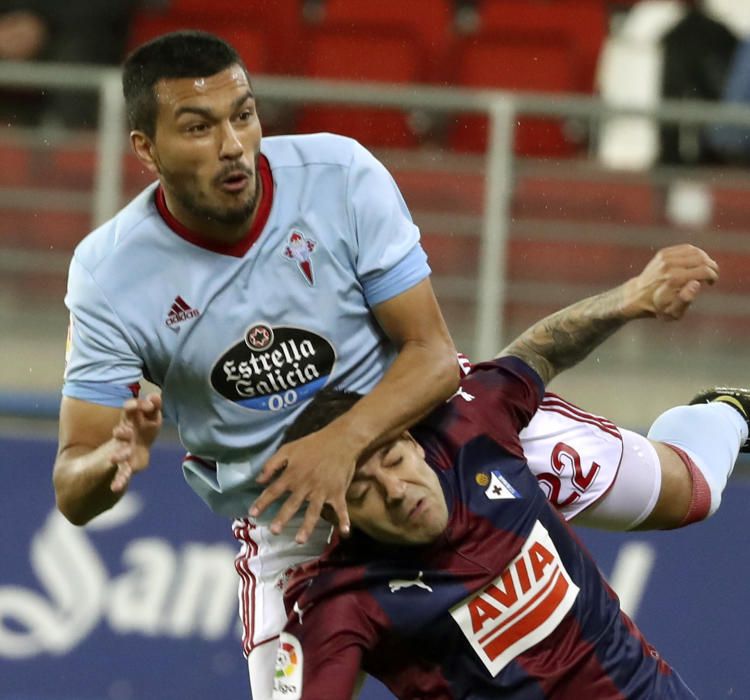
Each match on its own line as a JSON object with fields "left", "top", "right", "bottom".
{"left": 449, "top": 34, "right": 580, "bottom": 156}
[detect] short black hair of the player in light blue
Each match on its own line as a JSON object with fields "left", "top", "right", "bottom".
{"left": 122, "top": 30, "right": 247, "bottom": 138}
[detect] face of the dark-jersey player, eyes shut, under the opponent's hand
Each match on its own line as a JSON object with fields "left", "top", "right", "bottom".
{"left": 346, "top": 433, "right": 448, "bottom": 545}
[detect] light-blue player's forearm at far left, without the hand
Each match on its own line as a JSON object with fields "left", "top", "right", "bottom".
{"left": 53, "top": 440, "right": 122, "bottom": 525}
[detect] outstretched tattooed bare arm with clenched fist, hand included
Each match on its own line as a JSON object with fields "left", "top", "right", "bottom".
{"left": 498, "top": 244, "right": 719, "bottom": 384}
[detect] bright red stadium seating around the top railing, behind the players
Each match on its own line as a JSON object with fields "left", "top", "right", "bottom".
{"left": 125, "top": 0, "right": 608, "bottom": 157}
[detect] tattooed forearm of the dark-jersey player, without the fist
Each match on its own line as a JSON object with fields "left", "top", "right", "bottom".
{"left": 500, "top": 287, "right": 629, "bottom": 384}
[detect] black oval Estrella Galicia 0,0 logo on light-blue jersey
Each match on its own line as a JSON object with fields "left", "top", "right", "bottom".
{"left": 211, "top": 322, "right": 336, "bottom": 411}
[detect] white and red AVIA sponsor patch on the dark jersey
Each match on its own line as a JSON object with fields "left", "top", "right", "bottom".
{"left": 450, "top": 520, "right": 580, "bottom": 676}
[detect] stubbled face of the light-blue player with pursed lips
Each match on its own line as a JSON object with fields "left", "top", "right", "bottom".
{"left": 142, "top": 65, "right": 261, "bottom": 241}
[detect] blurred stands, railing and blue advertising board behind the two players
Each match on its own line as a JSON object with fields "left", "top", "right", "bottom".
{"left": 0, "top": 0, "right": 750, "bottom": 700}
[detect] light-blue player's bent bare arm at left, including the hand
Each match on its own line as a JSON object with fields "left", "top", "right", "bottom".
{"left": 53, "top": 396, "right": 161, "bottom": 525}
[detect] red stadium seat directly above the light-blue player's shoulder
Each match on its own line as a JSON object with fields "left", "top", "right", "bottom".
{"left": 297, "top": 26, "right": 421, "bottom": 148}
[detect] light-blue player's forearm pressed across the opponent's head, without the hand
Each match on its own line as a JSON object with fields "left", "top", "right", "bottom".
{"left": 328, "top": 337, "right": 459, "bottom": 456}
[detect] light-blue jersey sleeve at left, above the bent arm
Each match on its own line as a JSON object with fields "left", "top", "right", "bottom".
{"left": 62, "top": 257, "right": 143, "bottom": 408}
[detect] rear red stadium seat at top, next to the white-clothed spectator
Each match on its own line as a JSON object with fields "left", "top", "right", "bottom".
{"left": 477, "top": 0, "right": 608, "bottom": 92}
